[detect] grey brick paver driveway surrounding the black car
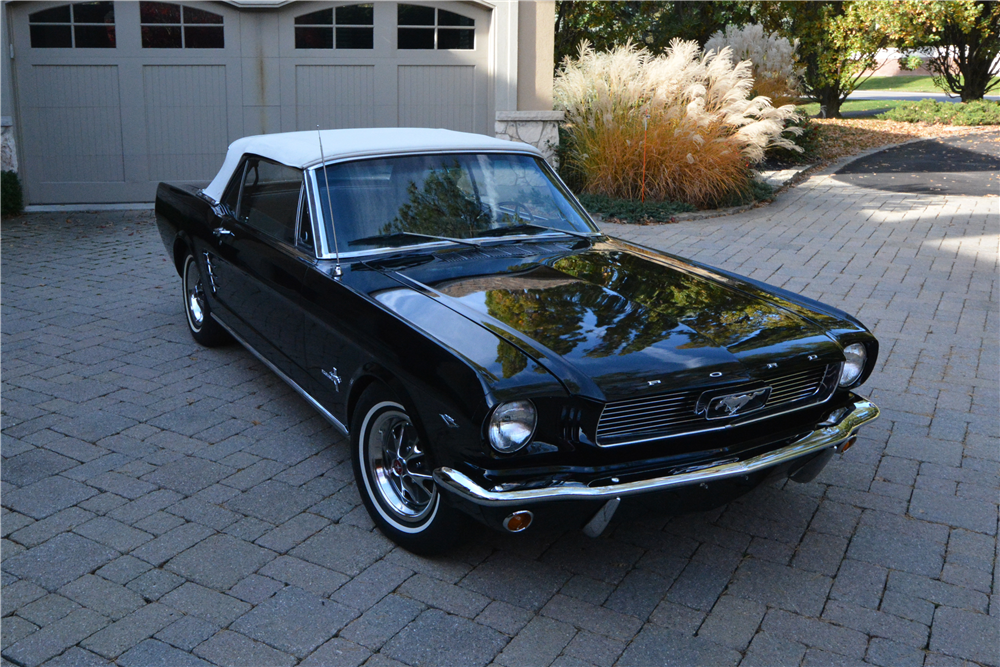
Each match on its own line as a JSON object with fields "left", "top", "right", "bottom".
{"left": 2, "top": 151, "right": 1000, "bottom": 667}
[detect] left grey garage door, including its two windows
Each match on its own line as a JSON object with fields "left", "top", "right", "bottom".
{"left": 12, "top": 2, "right": 243, "bottom": 204}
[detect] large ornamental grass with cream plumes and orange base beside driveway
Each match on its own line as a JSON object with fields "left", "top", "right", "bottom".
{"left": 554, "top": 39, "right": 799, "bottom": 208}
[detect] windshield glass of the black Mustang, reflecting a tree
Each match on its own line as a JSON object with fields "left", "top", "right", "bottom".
{"left": 316, "top": 153, "right": 597, "bottom": 252}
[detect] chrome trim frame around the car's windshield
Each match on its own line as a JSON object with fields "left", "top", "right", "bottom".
{"left": 303, "top": 147, "right": 607, "bottom": 260}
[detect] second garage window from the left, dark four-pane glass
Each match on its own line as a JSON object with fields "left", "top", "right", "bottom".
{"left": 139, "top": 2, "right": 226, "bottom": 49}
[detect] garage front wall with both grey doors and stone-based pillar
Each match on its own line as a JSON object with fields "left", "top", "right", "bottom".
{"left": 0, "top": 0, "right": 558, "bottom": 204}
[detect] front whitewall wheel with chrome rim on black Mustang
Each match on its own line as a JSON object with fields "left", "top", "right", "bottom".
{"left": 351, "top": 385, "right": 466, "bottom": 554}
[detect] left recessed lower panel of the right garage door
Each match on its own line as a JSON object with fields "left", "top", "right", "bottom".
{"left": 295, "top": 65, "right": 375, "bottom": 130}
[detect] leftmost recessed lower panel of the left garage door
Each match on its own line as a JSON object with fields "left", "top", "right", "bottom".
{"left": 24, "top": 65, "right": 125, "bottom": 183}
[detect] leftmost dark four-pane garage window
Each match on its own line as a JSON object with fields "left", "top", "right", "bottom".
{"left": 28, "top": 2, "right": 115, "bottom": 49}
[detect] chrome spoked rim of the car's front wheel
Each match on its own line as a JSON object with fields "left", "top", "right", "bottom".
{"left": 365, "top": 410, "right": 437, "bottom": 523}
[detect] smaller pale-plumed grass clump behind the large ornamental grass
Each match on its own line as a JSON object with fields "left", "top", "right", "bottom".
{"left": 705, "top": 24, "right": 802, "bottom": 107}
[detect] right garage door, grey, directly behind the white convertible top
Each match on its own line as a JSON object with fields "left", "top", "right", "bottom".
{"left": 279, "top": 2, "right": 495, "bottom": 135}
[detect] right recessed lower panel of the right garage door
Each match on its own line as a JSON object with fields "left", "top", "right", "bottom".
{"left": 397, "top": 65, "right": 476, "bottom": 132}
